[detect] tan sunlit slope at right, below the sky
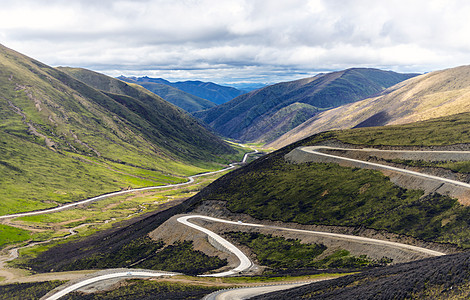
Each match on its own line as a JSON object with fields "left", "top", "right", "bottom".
{"left": 270, "top": 66, "right": 470, "bottom": 148}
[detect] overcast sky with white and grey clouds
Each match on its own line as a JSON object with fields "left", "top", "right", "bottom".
{"left": 0, "top": 0, "right": 470, "bottom": 83}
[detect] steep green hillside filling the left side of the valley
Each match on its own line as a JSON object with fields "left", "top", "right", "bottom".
{"left": 0, "top": 46, "right": 237, "bottom": 215}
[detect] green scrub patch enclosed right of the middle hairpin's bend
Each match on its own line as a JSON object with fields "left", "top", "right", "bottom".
{"left": 226, "top": 232, "right": 390, "bottom": 269}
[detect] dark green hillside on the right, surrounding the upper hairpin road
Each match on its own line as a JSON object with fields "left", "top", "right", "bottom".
{"left": 187, "top": 114, "right": 470, "bottom": 247}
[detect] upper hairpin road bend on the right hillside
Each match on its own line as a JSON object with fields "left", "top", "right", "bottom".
{"left": 297, "top": 146, "right": 470, "bottom": 189}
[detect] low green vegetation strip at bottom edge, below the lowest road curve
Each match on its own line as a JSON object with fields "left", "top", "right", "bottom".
{"left": 63, "top": 279, "right": 222, "bottom": 300}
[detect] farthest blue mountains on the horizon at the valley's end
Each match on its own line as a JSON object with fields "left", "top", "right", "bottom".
{"left": 118, "top": 76, "right": 245, "bottom": 106}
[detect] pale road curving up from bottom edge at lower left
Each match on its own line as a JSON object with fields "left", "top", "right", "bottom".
{"left": 44, "top": 270, "right": 181, "bottom": 300}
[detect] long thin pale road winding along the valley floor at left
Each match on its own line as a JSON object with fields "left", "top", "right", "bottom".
{"left": 0, "top": 150, "right": 258, "bottom": 220}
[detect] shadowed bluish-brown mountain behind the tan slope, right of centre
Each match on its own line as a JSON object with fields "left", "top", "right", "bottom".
{"left": 194, "top": 68, "right": 417, "bottom": 142}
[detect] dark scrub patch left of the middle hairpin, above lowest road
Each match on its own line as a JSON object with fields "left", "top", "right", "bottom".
{"left": 59, "top": 236, "right": 227, "bottom": 275}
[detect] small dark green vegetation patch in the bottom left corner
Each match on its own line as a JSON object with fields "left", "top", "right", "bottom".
{"left": 0, "top": 280, "right": 65, "bottom": 300}
